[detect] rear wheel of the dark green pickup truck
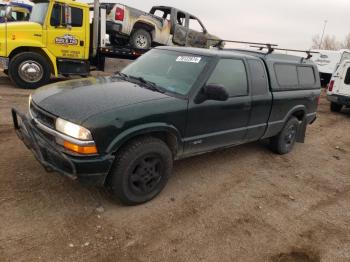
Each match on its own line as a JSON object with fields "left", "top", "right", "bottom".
{"left": 270, "top": 117, "right": 299, "bottom": 155}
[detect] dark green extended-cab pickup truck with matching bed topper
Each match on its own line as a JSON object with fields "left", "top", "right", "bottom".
{"left": 12, "top": 47, "right": 321, "bottom": 205}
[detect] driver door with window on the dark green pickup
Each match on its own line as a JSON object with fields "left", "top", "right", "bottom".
{"left": 185, "top": 58, "right": 251, "bottom": 155}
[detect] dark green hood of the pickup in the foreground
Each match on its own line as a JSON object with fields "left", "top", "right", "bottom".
{"left": 32, "top": 77, "right": 172, "bottom": 124}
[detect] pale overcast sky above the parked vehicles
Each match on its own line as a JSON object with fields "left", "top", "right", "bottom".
{"left": 81, "top": 0, "right": 350, "bottom": 49}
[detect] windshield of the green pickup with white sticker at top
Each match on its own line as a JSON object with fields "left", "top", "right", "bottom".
{"left": 122, "top": 49, "right": 211, "bottom": 95}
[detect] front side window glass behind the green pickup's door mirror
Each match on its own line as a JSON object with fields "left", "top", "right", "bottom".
{"left": 207, "top": 59, "right": 248, "bottom": 97}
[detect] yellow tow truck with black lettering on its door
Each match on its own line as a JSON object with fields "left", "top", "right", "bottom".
{"left": 0, "top": 0, "right": 146, "bottom": 88}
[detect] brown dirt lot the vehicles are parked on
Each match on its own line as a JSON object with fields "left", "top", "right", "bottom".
{"left": 0, "top": 62, "right": 350, "bottom": 262}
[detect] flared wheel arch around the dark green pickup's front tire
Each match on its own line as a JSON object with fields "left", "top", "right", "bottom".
{"left": 106, "top": 123, "right": 183, "bottom": 154}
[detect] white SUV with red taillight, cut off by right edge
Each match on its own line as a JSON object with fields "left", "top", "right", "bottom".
{"left": 327, "top": 60, "right": 350, "bottom": 112}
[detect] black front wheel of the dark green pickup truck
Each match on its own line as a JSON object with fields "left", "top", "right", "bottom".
{"left": 107, "top": 137, "right": 173, "bottom": 205}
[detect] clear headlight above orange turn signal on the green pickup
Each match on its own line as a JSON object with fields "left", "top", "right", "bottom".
{"left": 56, "top": 118, "right": 92, "bottom": 140}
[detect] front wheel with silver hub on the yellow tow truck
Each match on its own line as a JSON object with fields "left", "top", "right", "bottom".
{"left": 9, "top": 52, "right": 51, "bottom": 89}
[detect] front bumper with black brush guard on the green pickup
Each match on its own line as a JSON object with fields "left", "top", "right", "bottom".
{"left": 12, "top": 109, "right": 114, "bottom": 186}
